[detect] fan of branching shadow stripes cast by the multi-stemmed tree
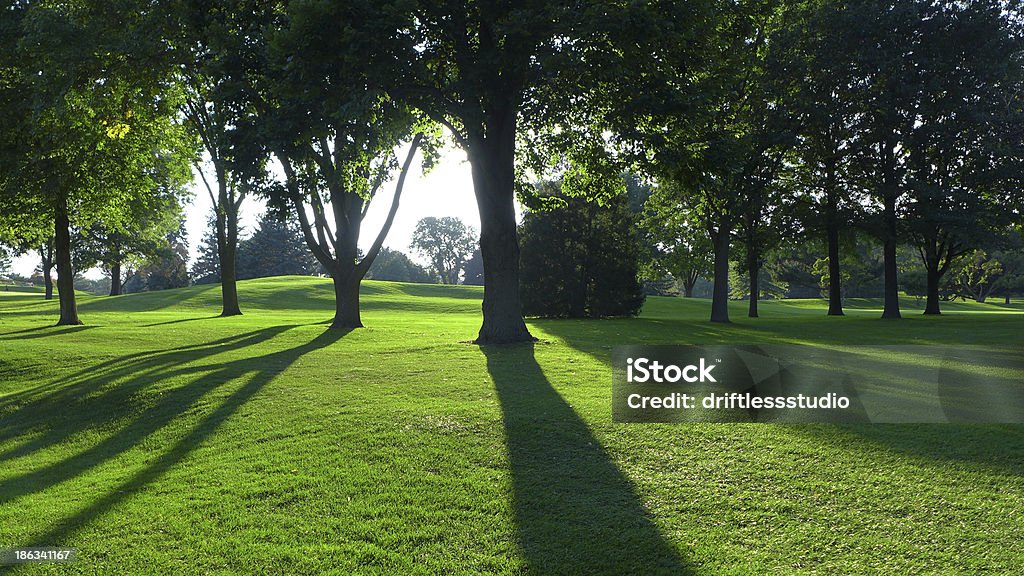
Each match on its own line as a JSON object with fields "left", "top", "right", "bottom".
{"left": 0, "top": 326, "right": 347, "bottom": 546}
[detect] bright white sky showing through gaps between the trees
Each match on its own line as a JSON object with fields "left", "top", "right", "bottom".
{"left": 12, "top": 147, "right": 521, "bottom": 278}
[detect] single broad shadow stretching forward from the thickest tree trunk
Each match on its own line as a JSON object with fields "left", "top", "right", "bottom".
{"left": 480, "top": 344, "right": 693, "bottom": 575}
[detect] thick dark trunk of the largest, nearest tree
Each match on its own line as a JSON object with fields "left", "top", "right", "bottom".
{"left": 467, "top": 106, "right": 537, "bottom": 344}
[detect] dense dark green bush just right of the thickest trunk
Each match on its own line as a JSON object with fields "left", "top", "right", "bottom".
{"left": 519, "top": 182, "right": 645, "bottom": 318}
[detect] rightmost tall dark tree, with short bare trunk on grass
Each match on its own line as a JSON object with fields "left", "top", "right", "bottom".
{"left": 903, "top": 2, "right": 1024, "bottom": 315}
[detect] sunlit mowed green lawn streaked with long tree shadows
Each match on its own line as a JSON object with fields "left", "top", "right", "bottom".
{"left": 0, "top": 277, "right": 1024, "bottom": 575}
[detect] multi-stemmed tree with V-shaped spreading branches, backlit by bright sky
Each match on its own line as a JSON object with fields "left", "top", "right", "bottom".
{"left": 218, "top": 1, "right": 435, "bottom": 330}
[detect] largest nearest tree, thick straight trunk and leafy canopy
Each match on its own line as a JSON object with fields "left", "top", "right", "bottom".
{"left": 395, "top": 0, "right": 699, "bottom": 344}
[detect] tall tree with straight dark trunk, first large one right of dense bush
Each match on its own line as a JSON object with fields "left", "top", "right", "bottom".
{"left": 614, "top": 1, "right": 781, "bottom": 323}
